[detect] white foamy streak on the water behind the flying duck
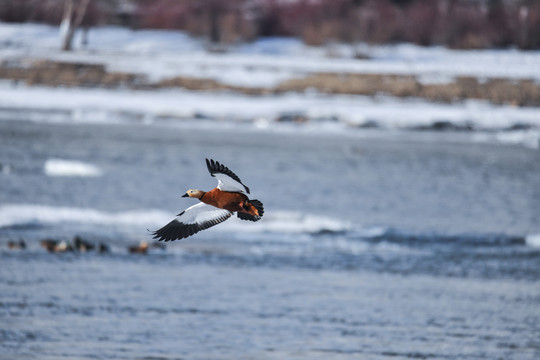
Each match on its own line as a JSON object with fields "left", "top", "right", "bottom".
{"left": 0, "top": 204, "right": 540, "bottom": 254}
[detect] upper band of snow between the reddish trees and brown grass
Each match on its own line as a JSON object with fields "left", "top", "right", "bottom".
{"left": 0, "top": 23, "right": 540, "bottom": 86}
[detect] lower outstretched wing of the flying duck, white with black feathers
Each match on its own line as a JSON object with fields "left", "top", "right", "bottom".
{"left": 152, "top": 203, "right": 232, "bottom": 241}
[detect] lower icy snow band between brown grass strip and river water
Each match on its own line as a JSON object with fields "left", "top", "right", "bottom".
{"left": 0, "top": 83, "right": 540, "bottom": 149}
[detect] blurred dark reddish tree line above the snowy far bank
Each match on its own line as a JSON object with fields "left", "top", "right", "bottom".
{"left": 0, "top": 0, "right": 540, "bottom": 49}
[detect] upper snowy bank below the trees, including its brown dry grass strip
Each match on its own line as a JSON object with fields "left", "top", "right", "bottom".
{"left": 0, "top": 23, "right": 540, "bottom": 106}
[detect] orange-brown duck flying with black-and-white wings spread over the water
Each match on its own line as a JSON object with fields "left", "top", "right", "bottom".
{"left": 152, "top": 159, "right": 264, "bottom": 241}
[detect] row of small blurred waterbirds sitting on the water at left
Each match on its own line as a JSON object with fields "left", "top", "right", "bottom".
{"left": 2, "top": 236, "right": 165, "bottom": 254}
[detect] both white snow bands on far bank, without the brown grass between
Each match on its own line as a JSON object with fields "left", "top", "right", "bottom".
{"left": 0, "top": 23, "right": 540, "bottom": 148}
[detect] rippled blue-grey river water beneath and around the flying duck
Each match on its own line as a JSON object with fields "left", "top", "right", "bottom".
{"left": 0, "top": 113, "right": 540, "bottom": 359}
